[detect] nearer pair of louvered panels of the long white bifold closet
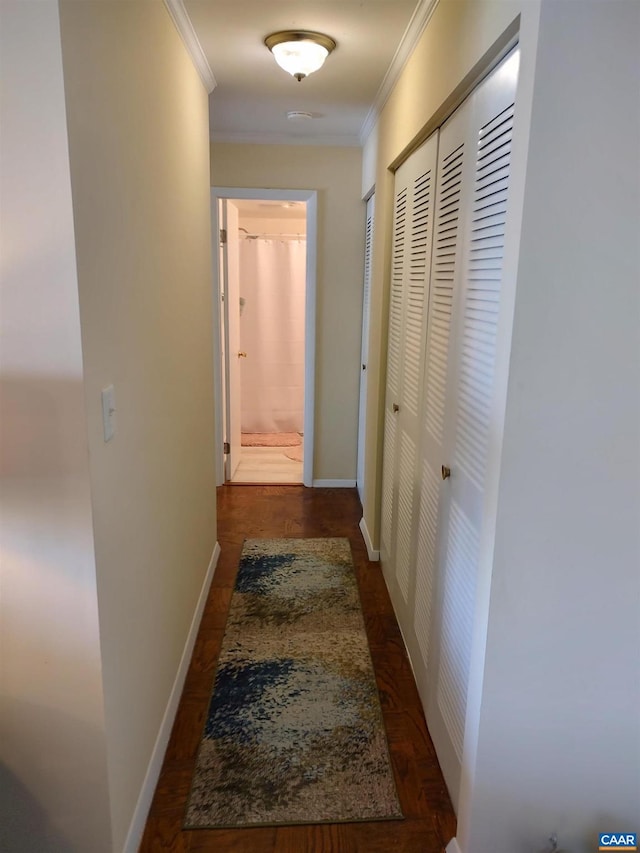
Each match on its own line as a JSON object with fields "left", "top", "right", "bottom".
{"left": 423, "top": 51, "right": 519, "bottom": 803}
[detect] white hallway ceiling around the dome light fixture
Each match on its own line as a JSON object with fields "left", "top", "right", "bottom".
{"left": 184, "top": 0, "right": 428, "bottom": 145}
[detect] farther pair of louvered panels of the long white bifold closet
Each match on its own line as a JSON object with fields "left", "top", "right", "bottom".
{"left": 381, "top": 134, "right": 438, "bottom": 607}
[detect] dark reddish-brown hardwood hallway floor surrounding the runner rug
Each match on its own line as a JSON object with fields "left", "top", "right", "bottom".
{"left": 140, "top": 486, "right": 456, "bottom": 853}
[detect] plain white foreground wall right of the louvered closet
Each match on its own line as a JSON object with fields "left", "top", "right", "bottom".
{"left": 458, "top": 0, "right": 640, "bottom": 853}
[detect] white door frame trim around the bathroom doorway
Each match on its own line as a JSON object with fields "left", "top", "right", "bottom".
{"left": 211, "top": 187, "right": 318, "bottom": 486}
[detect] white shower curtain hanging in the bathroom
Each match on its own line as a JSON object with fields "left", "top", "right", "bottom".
{"left": 240, "top": 237, "right": 306, "bottom": 433}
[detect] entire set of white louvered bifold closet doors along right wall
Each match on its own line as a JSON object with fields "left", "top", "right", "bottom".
{"left": 381, "top": 50, "right": 519, "bottom": 806}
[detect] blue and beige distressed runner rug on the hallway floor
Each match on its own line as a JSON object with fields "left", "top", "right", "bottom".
{"left": 185, "top": 539, "right": 402, "bottom": 829}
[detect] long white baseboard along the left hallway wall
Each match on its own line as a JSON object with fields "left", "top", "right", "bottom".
{"left": 123, "top": 542, "right": 220, "bottom": 853}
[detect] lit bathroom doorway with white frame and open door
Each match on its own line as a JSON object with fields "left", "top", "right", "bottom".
{"left": 212, "top": 188, "right": 316, "bottom": 485}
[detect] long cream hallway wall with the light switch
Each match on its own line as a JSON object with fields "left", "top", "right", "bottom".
{"left": 61, "top": 5, "right": 216, "bottom": 850}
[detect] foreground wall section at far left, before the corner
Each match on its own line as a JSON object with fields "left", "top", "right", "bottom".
{"left": 0, "top": 2, "right": 111, "bottom": 853}
